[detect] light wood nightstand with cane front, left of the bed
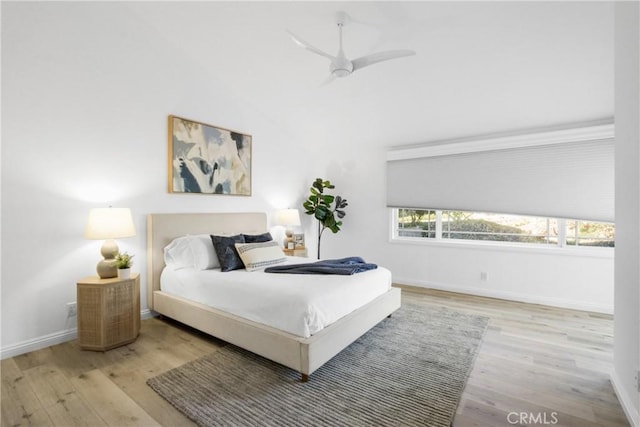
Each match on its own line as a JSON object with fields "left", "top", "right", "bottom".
{"left": 77, "top": 273, "right": 140, "bottom": 351}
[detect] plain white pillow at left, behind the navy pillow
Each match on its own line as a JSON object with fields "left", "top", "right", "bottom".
{"left": 164, "top": 234, "right": 220, "bottom": 270}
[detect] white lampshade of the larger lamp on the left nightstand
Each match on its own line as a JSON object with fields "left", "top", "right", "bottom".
{"left": 84, "top": 208, "right": 136, "bottom": 240}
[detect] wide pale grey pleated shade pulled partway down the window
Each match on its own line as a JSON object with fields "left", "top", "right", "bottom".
{"left": 387, "top": 138, "right": 614, "bottom": 222}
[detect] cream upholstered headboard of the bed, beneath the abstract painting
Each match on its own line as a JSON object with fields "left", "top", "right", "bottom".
{"left": 147, "top": 212, "right": 267, "bottom": 310}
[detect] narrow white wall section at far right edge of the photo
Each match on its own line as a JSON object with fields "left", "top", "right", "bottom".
{"left": 612, "top": 2, "right": 640, "bottom": 426}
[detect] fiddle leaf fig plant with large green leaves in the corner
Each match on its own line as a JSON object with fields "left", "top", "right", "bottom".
{"left": 302, "top": 178, "right": 348, "bottom": 259}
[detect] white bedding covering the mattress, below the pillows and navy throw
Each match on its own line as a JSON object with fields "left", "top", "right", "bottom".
{"left": 160, "top": 257, "right": 391, "bottom": 338}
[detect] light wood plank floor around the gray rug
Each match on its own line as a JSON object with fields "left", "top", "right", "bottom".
{"left": 1, "top": 288, "right": 629, "bottom": 427}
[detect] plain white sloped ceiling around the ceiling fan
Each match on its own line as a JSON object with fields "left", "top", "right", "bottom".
{"left": 131, "top": 1, "right": 614, "bottom": 150}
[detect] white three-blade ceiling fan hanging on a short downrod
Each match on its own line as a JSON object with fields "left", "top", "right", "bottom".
{"left": 288, "top": 12, "right": 416, "bottom": 79}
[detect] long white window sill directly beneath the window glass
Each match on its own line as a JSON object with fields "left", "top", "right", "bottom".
{"left": 389, "top": 237, "right": 615, "bottom": 259}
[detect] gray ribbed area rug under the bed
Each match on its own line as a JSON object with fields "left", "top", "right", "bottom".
{"left": 147, "top": 305, "right": 488, "bottom": 427}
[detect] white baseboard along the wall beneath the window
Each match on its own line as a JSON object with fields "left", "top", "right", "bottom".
{"left": 393, "top": 276, "right": 613, "bottom": 314}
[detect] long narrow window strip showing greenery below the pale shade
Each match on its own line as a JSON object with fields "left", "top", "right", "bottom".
{"left": 394, "top": 208, "right": 615, "bottom": 247}
